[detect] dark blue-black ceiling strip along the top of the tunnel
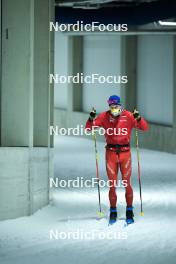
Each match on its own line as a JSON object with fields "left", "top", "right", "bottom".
{"left": 55, "top": 0, "right": 176, "bottom": 30}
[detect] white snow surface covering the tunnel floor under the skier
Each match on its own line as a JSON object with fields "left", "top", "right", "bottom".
{"left": 0, "top": 136, "right": 176, "bottom": 264}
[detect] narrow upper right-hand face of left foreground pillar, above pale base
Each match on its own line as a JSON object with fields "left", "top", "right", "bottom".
{"left": 31, "top": 0, "right": 53, "bottom": 147}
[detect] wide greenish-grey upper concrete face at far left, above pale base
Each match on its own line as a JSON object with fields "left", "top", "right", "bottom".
{"left": 1, "top": 0, "right": 30, "bottom": 146}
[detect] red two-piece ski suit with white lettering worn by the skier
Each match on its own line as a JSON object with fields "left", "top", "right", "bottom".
{"left": 86, "top": 110, "right": 148, "bottom": 207}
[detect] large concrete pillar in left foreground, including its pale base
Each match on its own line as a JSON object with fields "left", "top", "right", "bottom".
{"left": 0, "top": 0, "right": 54, "bottom": 219}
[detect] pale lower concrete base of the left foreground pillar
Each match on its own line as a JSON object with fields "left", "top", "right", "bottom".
{"left": 0, "top": 147, "right": 53, "bottom": 220}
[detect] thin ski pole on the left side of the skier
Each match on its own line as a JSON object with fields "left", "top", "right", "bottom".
{"left": 93, "top": 108, "right": 104, "bottom": 217}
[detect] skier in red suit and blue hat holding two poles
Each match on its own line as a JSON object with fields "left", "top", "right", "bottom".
{"left": 86, "top": 95, "right": 148, "bottom": 224}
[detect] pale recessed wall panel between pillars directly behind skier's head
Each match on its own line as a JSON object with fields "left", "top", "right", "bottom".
{"left": 82, "top": 35, "right": 122, "bottom": 112}
